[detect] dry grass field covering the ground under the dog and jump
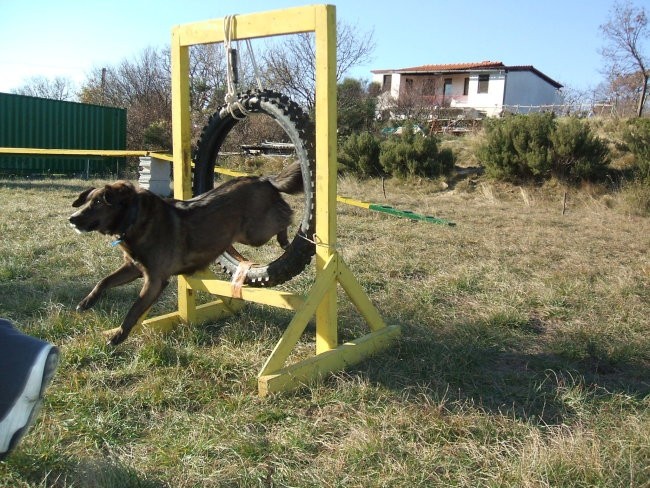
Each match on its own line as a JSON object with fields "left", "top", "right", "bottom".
{"left": 0, "top": 179, "right": 650, "bottom": 488}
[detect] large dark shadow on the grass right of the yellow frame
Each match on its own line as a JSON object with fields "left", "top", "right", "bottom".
{"left": 357, "top": 323, "right": 650, "bottom": 424}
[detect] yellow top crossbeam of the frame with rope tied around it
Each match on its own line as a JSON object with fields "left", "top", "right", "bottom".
{"left": 173, "top": 5, "right": 325, "bottom": 46}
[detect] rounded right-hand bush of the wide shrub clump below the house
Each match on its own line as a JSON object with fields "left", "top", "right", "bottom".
{"left": 550, "top": 117, "right": 609, "bottom": 182}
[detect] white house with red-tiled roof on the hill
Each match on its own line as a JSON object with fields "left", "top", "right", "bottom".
{"left": 372, "top": 61, "right": 562, "bottom": 116}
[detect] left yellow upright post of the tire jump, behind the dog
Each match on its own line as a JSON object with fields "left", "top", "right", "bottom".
{"left": 171, "top": 29, "right": 196, "bottom": 322}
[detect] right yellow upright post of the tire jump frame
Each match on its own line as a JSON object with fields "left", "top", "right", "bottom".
{"left": 315, "top": 5, "right": 338, "bottom": 354}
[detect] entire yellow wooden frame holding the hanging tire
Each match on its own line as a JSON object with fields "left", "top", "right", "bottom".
{"left": 142, "top": 5, "right": 400, "bottom": 396}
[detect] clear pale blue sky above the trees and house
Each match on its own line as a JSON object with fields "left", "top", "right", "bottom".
{"left": 0, "top": 0, "right": 624, "bottom": 91}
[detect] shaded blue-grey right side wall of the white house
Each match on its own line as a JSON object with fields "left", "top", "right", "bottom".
{"left": 503, "top": 71, "right": 562, "bottom": 113}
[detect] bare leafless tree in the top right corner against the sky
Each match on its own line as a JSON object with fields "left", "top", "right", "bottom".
{"left": 600, "top": 1, "right": 650, "bottom": 117}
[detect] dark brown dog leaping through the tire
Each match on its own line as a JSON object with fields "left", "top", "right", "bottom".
{"left": 69, "top": 162, "right": 303, "bottom": 345}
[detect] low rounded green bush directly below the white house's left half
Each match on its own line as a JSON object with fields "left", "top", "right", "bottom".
{"left": 379, "top": 125, "right": 454, "bottom": 178}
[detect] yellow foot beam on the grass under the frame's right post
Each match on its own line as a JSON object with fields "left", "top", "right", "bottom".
{"left": 258, "top": 325, "right": 401, "bottom": 397}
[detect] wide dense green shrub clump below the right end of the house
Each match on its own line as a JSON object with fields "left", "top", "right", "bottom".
{"left": 477, "top": 113, "right": 609, "bottom": 182}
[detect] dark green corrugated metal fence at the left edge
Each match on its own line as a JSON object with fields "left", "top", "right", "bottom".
{"left": 0, "top": 93, "right": 126, "bottom": 176}
